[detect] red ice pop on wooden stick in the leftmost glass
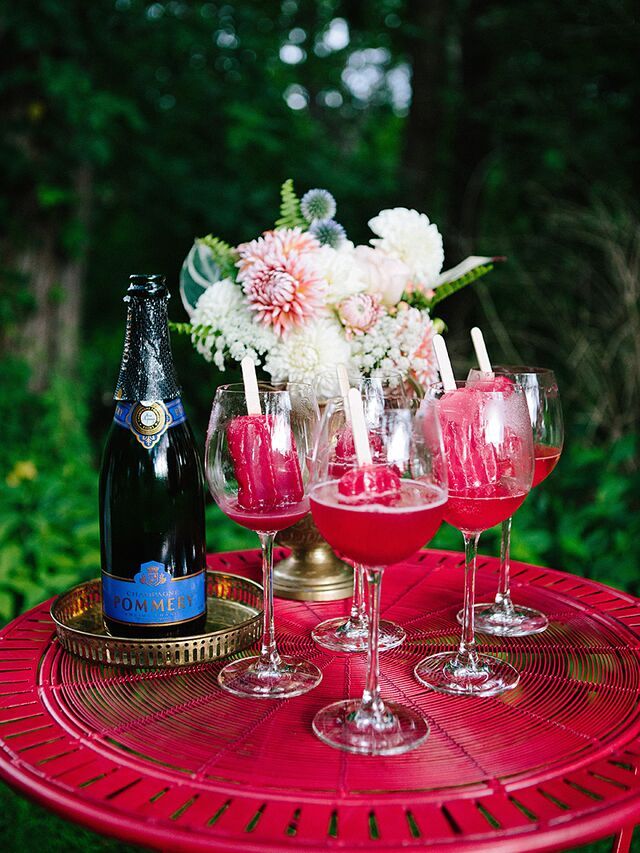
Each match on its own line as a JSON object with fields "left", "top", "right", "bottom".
{"left": 227, "top": 359, "right": 304, "bottom": 512}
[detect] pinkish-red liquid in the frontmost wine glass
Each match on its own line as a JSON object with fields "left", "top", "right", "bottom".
{"left": 311, "top": 480, "right": 446, "bottom": 566}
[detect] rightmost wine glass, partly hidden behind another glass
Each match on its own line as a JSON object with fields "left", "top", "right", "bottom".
{"left": 458, "top": 366, "right": 564, "bottom": 637}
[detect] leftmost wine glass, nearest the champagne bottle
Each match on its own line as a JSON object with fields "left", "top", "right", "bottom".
{"left": 205, "top": 384, "right": 322, "bottom": 699}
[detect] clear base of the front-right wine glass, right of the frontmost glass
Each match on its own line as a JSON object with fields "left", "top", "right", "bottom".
{"left": 413, "top": 652, "right": 520, "bottom": 696}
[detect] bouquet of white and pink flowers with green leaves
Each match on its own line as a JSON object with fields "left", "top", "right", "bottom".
{"left": 173, "top": 180, "right": 497, "bottom": 398}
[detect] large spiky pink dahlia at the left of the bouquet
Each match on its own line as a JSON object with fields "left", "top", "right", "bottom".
{"left": 238, "top": 228, "right": 324, "bottom": 336}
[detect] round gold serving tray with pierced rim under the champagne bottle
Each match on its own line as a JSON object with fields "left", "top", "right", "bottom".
{"left": 50, "top": 569, "right": 263, "bottom": 667}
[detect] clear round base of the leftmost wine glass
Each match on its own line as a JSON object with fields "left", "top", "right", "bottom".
{"left": 218, "top": 656, "right": 322, "bottom": 699}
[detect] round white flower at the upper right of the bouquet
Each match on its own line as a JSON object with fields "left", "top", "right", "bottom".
{"left": 369, "top": 207, "right": 444, "bottom": 286}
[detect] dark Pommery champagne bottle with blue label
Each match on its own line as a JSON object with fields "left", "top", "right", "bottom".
{"left": 100, "top": 275, "right": 206, "bottom": 639}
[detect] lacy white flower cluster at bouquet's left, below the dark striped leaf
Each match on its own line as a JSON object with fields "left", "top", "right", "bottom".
{"left": 191, "top": 278, "right": 276, "bottom": 370}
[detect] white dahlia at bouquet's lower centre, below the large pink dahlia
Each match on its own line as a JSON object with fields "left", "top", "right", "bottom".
{"left": 264, "top": 317, "right": 351, "bottom": 397}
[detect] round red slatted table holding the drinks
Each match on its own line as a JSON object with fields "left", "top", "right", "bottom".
{"left": 0, "top": 551, "right": 640, "bottom": 853}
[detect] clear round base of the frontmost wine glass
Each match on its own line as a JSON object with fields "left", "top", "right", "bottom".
{"left": 313, "top": 699, "right": 429, "bottom": 755}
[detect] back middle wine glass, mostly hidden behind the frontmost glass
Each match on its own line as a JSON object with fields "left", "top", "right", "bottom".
{"left": 311, "top": 369, "right": 407, "bottom": 652}
